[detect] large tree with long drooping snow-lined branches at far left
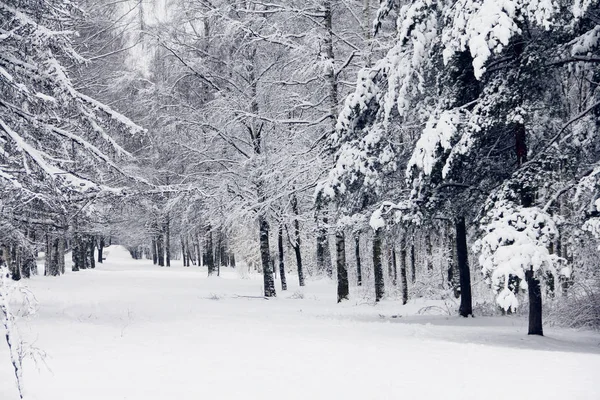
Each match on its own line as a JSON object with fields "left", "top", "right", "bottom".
{"left": 0, "top": 1, "right": 145, "bottom": 277}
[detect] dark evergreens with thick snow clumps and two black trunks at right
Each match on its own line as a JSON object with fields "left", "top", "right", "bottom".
{"left": 318, "top": 1, "right": 600, "bottom": 335}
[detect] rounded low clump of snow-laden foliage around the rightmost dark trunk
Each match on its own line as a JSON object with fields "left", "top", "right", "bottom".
{"left": 474, "top": 202, "right": 570, "bottom": 311}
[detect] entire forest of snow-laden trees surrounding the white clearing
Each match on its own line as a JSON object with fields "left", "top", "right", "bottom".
{"left": 0, "top": 0, "right": 600, "bottom": 340}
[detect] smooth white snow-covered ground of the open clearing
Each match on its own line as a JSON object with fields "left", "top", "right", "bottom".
{"left": 0, "top": 246, "right": 600, "bottom": 400}
